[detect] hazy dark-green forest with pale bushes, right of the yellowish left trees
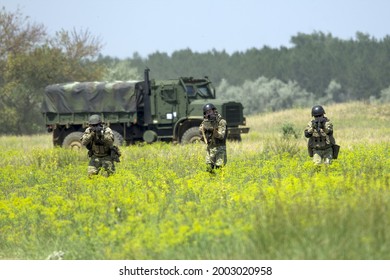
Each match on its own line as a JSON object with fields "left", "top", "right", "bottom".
{"left": 116, "top": 32, "right": 390, "bottom": 114}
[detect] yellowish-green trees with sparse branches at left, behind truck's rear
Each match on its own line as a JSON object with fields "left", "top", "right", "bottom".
{"left": 0, "top": 8, "right": 104, "bottom": 134}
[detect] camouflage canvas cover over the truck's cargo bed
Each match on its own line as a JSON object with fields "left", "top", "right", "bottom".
{"left": 42, "top": 82, "right": 142, "bottom": 114}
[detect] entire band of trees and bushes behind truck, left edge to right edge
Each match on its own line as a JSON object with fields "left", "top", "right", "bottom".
{"left": 0, "top": 8, "right": 390, "bottom": 134}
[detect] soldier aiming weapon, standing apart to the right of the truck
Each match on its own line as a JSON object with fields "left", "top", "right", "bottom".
{"left": 304, "top": 105, "right": 336, "bottom": 165}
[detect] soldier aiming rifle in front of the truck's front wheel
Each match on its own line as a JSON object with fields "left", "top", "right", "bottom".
{"left": 199, "top": 103, "right": 227, "bottom": 172}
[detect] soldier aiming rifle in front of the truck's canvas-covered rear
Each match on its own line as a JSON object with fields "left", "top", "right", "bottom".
{"left": 80, "top": 115, "right": 115, "bottom": 177}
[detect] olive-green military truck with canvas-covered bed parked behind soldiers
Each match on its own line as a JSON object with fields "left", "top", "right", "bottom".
{"left": 42, "top": 69, "right": 249, "bottom": 148}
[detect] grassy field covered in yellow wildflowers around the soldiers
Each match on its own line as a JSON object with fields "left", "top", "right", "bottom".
{"left": 0, "top": 103, "right": 390, "bottom": 260}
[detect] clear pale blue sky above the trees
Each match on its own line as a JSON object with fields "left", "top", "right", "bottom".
{"left": 0, "top": 0, "right": 390, "bottom": 58}
